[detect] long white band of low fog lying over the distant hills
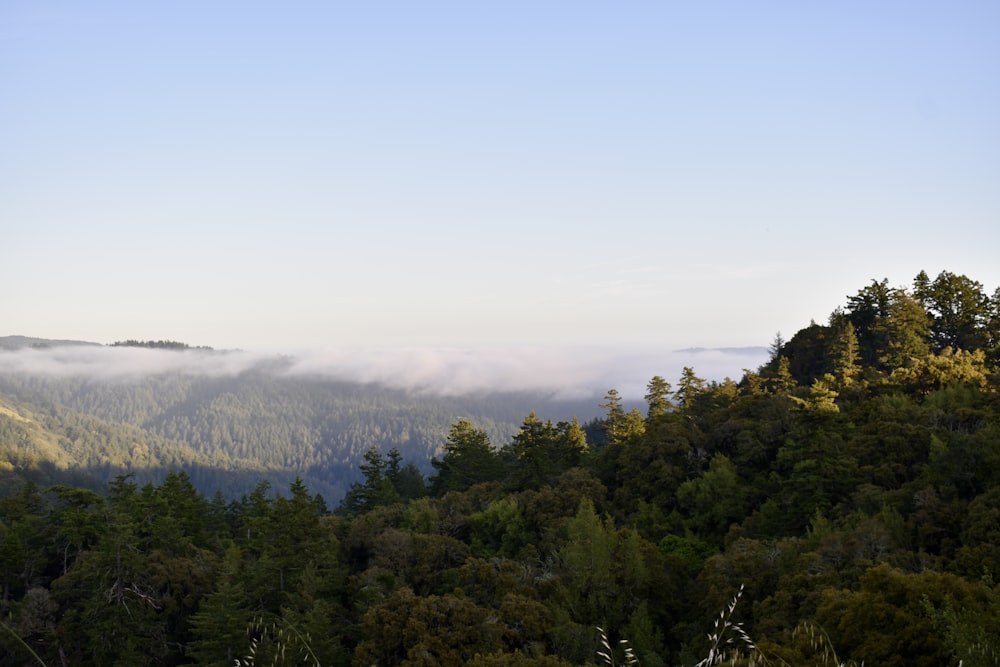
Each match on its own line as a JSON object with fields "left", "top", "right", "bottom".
{"left": 0, "top": 346, "right": 767, "bottom": 399}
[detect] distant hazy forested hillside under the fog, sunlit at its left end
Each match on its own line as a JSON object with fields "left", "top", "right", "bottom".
{"left": 0, "top": 350, "right": 600, "bottom": 502}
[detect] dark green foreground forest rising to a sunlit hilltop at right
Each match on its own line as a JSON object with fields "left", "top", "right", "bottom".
{"left": 0, "top": 271, "right": 1000, "bottom": 667}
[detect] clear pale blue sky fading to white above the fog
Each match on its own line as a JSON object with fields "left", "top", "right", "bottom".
{"left": 0, "top": 0, "right": 1000, "bottom": 386}
